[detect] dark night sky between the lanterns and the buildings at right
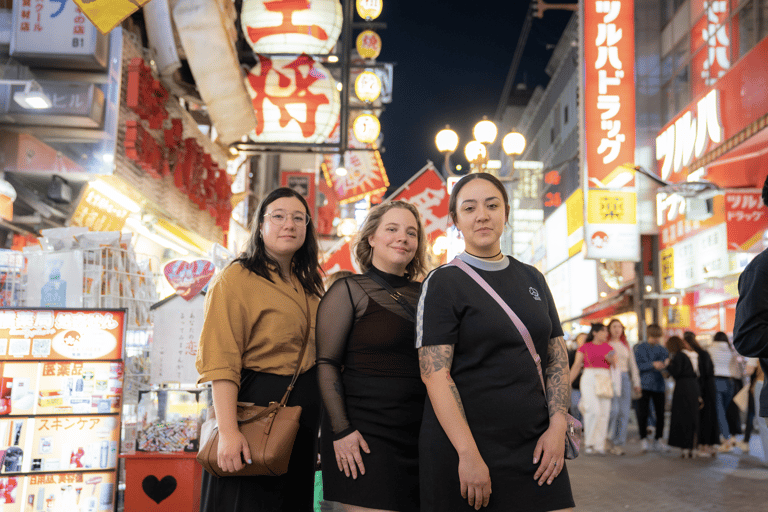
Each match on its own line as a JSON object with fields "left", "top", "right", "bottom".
{"left": 376, "top": 0, "right": 572, "bottom": 193}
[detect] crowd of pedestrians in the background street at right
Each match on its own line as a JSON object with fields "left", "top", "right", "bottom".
{"left": 569, "top": 318, "right": 768, "bottom": 461}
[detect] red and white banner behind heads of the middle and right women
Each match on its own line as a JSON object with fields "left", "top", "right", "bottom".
{"left": 387, "top": 162, "right": 450, "bottom": 243}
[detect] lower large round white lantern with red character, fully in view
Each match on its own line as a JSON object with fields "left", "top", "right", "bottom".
{"left": 245, "top": 55, "right": 341, "bottom": 143}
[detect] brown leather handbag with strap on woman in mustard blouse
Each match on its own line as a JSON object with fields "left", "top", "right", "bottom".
{"left": 197, "top": 297, "right": 312, "bottom": 477}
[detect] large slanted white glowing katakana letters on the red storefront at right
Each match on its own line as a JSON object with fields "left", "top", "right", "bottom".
{"left": 656, "top": 89, "right": 723, "bottom": 180}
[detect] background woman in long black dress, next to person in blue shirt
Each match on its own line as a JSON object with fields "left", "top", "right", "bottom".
{"left": 667, "top": 336, "right": 701, "bottom": 459}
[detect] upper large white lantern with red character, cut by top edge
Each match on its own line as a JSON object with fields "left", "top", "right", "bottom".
{"left": 240, "top": 0, "right": 344, "bottom": 55}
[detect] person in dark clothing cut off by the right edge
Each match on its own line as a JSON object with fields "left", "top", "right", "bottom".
{"left": 733, "top": 176, "right": 768, "bottom": 463}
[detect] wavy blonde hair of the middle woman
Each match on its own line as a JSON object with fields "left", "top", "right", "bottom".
{"left": 354, "top": 201, "right": 427, "bottom": 280}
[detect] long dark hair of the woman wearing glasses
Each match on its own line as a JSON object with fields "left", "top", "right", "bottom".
{"left": 233, "top": 187, "right": 323, "bottom": 297}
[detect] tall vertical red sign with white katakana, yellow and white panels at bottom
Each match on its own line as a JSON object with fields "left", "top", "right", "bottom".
{"left": 583, "top": 0, "right": 640, "bottom": 261}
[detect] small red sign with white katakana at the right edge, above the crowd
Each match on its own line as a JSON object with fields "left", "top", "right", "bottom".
{"left": 725, "top": 189, "right": 768, "bottom": 251}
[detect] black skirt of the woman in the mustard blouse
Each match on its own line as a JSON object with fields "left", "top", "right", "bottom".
{"left": 200, "top": 367, "right": 321, "bottom": 512}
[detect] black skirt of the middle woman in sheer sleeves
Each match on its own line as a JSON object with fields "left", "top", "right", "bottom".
{"left": 321, "top": 371, "right": 426, "bottom": 512}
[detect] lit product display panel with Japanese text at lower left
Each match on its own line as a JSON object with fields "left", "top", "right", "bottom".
{"left": 0, "top": 309, "right": 125, "bottom": 512}
